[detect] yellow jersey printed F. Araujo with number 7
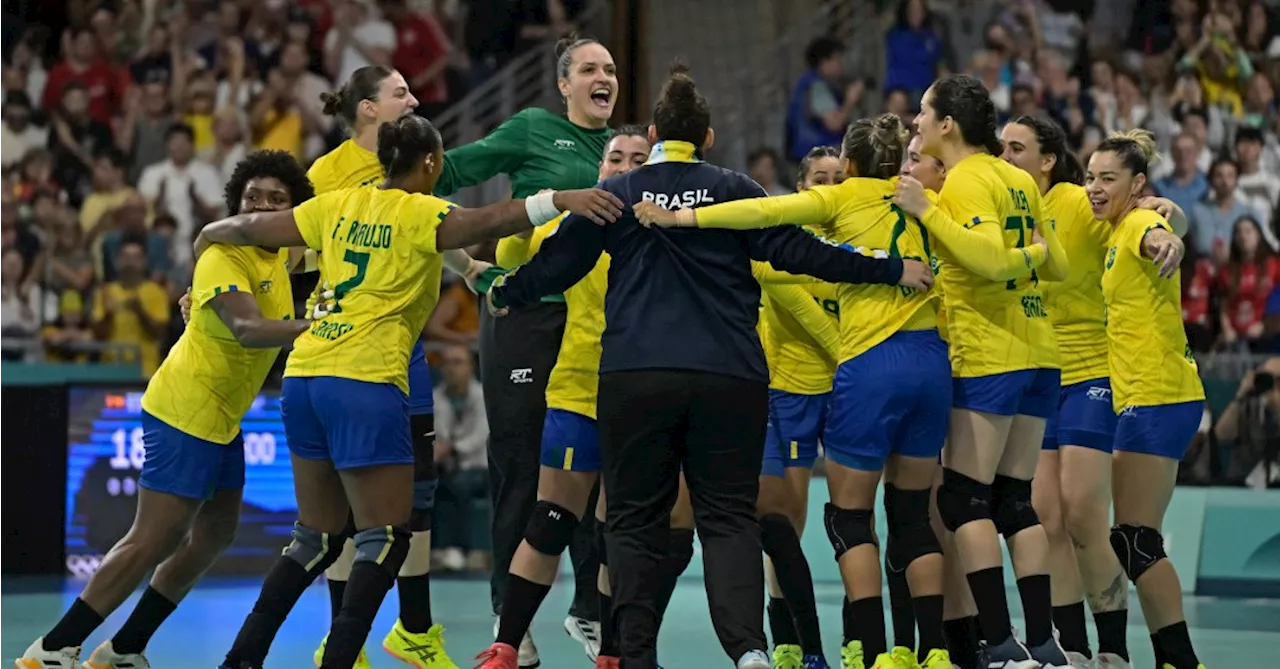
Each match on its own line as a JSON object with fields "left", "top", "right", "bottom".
{"left": 284, "top": 188, "right": 453, "bottom": 394}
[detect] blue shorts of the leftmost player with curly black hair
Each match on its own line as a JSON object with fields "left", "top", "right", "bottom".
{"left": 138, "top": 411, "right": 244, "bottom": 500}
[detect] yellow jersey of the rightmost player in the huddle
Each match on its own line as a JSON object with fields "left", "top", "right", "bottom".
{"left": 1102, "top": 209, "right": 1204, "bottom": 413}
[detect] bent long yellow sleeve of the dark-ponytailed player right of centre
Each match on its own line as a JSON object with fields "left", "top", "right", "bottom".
{"left": 920, "top": 173, "right": 1047, "bottom": 281}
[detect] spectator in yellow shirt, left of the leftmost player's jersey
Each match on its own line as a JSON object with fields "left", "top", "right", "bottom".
{"left": 93, "top": 237, "right": 169, "bottom": 379}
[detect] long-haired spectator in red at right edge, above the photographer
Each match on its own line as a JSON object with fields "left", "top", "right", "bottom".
{"left": 1219, "top": 216, "right": 1280, "bottom": 350}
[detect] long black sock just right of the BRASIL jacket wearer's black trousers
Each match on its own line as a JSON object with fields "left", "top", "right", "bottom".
{"left": 760, "top": 514, "right": 822, "bottom": 655}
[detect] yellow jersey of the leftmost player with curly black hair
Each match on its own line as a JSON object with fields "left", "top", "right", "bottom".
{"left": 142, "top": 244, "right": 293, "bottom": 444}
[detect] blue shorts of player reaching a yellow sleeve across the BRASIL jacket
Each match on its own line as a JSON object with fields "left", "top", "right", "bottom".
{"left": 822, "top": 330, "right": 951, "bottom": 472}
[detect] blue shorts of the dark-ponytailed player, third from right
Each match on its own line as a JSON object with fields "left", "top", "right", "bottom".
{"left": 952, "top": 370, "right": 1062, "bottom": 418}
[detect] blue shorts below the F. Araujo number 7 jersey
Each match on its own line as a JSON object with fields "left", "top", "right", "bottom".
{"left": 280, "top": 376, "right": 413, "bottom": 469}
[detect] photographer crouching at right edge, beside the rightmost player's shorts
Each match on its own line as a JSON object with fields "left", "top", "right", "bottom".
{"left": 1213, "top": 358, "right": 1280, "bottom": 487}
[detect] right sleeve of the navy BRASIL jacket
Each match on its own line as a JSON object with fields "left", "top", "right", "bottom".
{"left": 744, "top": 225, "right": 902, "bottom": 285}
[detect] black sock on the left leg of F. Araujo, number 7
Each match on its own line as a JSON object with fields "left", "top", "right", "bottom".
{"left": 225, "top": 555, "right": 324, "bottom": 666}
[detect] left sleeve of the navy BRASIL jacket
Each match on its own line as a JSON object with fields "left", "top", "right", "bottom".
{"left": 492, "top": 215, "right": 604, "bottom": 307}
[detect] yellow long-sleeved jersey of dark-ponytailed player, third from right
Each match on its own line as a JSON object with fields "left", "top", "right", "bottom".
{"left": 922, "top": 153, "right": 1069, "bottom": 377}
